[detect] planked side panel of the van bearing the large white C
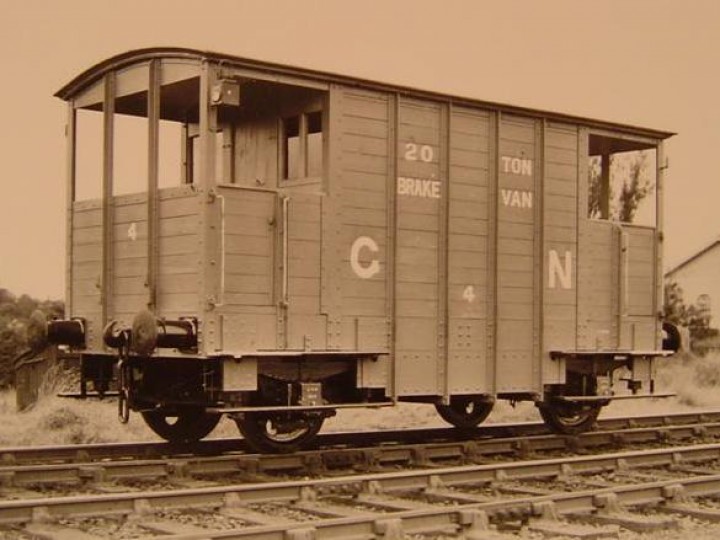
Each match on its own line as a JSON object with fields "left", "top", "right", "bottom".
{"left": 333, "top": 89, "right": 391, "bottom": 350}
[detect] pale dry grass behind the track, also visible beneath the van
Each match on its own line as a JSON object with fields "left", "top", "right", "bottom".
{"left": 0, "top": 354, "right": 720, "bottom": 447}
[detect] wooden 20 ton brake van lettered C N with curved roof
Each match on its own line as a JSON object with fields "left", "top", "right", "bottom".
{"left": 48, "top": 48, "right": 672, "bottom": 452}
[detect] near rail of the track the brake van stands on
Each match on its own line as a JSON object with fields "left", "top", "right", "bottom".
{"left": 0, "top": 416, "right": 720, "bottom": 487}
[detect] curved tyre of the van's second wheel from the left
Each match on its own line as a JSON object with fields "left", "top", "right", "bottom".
{"left": 235, "top": 412, "right": 324, "bottom": 454}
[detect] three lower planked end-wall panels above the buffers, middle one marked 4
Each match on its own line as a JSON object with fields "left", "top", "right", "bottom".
{"left": 72, "top": 188, "right": 200, "bottom": 349}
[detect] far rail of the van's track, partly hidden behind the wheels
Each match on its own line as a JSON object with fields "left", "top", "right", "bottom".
{"left": 0, "top": 410, "right": 720, "bottom": 465}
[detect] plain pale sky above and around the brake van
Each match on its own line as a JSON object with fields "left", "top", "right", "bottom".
{"left": 0, "top": 0, "right": 720, "bottom": 299}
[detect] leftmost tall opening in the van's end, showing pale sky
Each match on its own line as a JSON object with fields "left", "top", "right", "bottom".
{"left": 75, "top": 109, "right": 103, "bottom": 201}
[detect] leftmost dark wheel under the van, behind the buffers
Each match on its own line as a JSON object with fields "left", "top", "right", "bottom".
{"left": 142, "top": 408, "right": 221, "bottom": 443}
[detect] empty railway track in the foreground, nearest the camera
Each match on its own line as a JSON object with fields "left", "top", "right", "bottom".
{"left": 0, "top": 444, "right": 720, "bottom": 540}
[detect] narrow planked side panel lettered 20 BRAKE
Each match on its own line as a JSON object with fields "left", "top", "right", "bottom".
{"left": 395, "top": 98, "right": 447, "bottom": 395}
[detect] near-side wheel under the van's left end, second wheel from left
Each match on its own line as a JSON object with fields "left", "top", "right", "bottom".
{"left": 235, "top": 412, "right": 324, "bottom": 453}
